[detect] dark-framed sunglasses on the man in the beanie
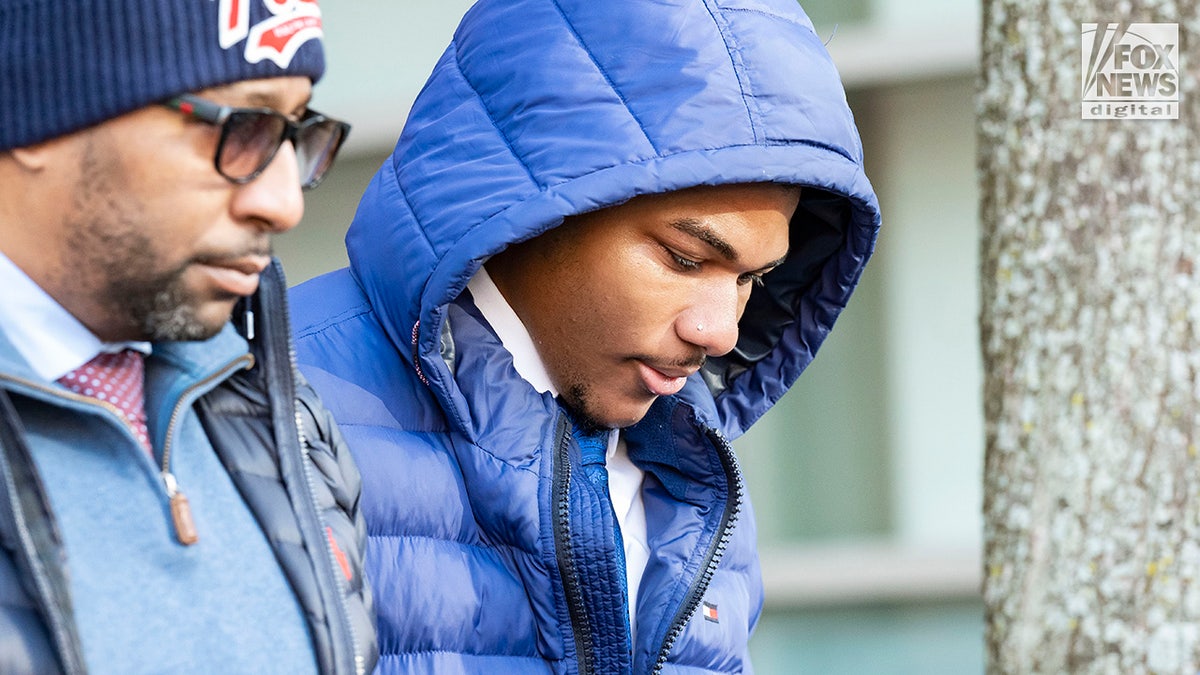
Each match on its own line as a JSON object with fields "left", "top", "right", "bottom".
{"left": 163, "top": 94, "right": 350, "bottom": 190}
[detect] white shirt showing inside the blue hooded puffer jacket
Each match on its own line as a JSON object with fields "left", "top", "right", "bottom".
{"left": 467, "top": 267, "right": 650, "bottom": 640}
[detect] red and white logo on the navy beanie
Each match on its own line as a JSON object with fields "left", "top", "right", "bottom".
{"left": 220, "top": 0, "right": 324, "bottom": 68}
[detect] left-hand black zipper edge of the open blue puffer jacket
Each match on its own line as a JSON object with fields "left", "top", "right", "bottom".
{"left": 552, "top": 414, "right": 594, "bottom": 675}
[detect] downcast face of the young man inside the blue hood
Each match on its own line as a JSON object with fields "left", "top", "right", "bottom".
{"left": 487, "top": 184, "right": 799, "bottom": 428}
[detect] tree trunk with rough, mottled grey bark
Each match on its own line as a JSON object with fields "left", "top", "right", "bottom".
{"left": 979, "top": 0, "right": 1200, "bottom": 675}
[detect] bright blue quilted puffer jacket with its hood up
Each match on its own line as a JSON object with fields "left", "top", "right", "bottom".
{"left": 293, "top": 0, "right": 880, "bottom": 675}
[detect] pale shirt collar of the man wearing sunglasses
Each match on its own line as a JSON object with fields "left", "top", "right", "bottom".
{"left": 0, "top": 253, "right": 150, "bottom": 382}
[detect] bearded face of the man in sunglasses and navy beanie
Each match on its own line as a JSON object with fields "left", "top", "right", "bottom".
{"left": 5, "top": 77, "right": 312, "bottom": 341}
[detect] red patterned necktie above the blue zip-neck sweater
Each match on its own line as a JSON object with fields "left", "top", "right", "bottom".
{"left": 59, "top": 350, "right": 154, "bottom": 455}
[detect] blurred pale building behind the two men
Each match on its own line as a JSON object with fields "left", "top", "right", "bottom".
{"left": 277, "top": 0, "right": 983, "bottom": 675}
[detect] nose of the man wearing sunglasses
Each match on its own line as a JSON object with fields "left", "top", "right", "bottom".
{"left": 232, "top": 142, "right": 304, "bottom": 233}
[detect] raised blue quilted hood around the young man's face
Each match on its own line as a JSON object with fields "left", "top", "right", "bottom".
{"left": 347, "top": 0, "right": 880, "bottom": 438}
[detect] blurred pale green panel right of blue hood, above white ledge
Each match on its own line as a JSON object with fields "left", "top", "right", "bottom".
{"left": 734, "top": 249, "right": 893, "bottom": 544}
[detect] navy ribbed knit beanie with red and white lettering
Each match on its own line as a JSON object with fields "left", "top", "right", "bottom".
{"left": 0, "top": 0, "right": 325, "bottom": 150}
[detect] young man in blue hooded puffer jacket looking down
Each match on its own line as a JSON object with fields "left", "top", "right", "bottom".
{"left": 293, "top": 0, "right": 880, "bottom": 675}
